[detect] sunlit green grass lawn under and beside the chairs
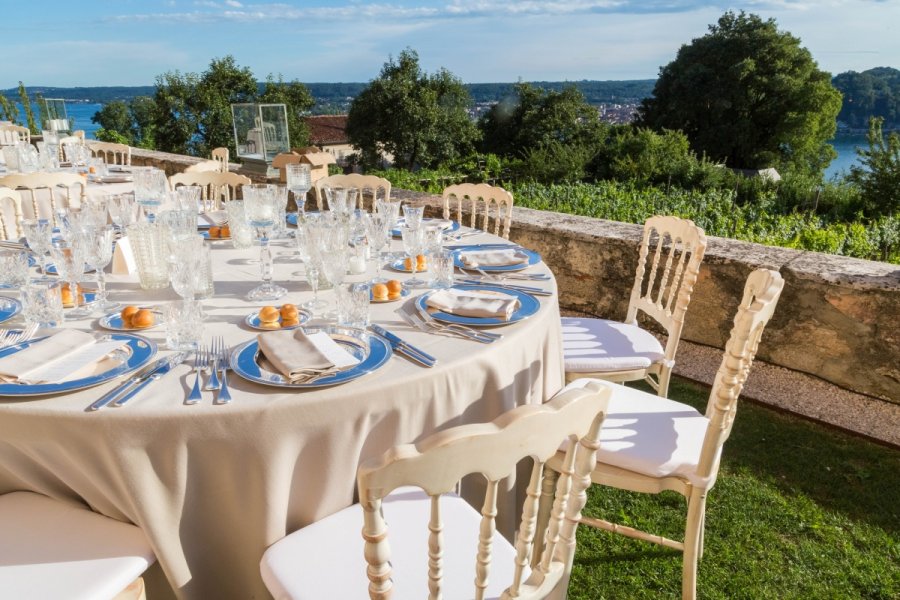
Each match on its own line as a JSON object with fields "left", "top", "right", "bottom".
{"left": 569, "top": 380, "right": 900, "bottom": 600}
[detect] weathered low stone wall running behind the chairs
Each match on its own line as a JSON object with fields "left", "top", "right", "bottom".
{"left": 392, "top": 190, "right": 900, "bottom": 403}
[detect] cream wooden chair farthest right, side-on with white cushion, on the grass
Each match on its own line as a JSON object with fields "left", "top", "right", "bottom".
{"left": 544, "top": 269, "right": 784, "bottom": 599}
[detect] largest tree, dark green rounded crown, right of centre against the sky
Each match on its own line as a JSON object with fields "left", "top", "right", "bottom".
{"left": 638, "top": 11, "right": 841, "bottom": 173}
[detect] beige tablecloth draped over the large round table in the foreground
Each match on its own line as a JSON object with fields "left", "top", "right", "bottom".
{"left": 0, "top": 197, "right": 563, "bottom": 600}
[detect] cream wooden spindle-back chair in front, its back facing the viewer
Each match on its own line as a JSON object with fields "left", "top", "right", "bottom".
{"left": 260, "top": 384, "right": 607, "bottom": 599}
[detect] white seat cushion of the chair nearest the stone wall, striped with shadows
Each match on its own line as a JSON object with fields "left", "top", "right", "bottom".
{"left": 562, "top": 317, "right": 665, "bottom": 373}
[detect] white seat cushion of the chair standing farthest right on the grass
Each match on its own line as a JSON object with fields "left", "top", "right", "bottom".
{"left": 564, "top": 378, "right": 713, "bottom": 486}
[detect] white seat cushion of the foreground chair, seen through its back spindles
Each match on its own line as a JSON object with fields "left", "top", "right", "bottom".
{"left": 260, "top": 488, "right": 527, "bottom": 600}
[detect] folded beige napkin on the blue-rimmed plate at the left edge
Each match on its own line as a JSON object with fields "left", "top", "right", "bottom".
{"left": 0, "top": 329, "right": 127, "bottom": 384}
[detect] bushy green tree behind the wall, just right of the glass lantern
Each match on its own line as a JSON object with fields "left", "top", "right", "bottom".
{"left": 347, "top": 48, "right": 478, "bottom": 169}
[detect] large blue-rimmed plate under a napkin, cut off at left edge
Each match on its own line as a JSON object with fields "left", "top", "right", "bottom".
{"left": 0, "top": 333, "right": 156, "bottom": 396}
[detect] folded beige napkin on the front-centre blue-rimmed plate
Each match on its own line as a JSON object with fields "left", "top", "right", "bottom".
{"left": 256, "top": 329, "right": 359, "bottom": 383}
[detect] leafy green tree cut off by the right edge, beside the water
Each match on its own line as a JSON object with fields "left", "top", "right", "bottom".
{"left": 849, "top": 117, "right": 900, "bottom": 216}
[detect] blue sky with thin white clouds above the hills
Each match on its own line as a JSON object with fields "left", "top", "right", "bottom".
{"left": 0, "top": 0, "right": 900, "bottom": 89}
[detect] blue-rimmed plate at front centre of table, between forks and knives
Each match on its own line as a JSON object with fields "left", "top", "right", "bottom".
{"left": 231, "top": 326, "right": 392, "bottom": 390}
